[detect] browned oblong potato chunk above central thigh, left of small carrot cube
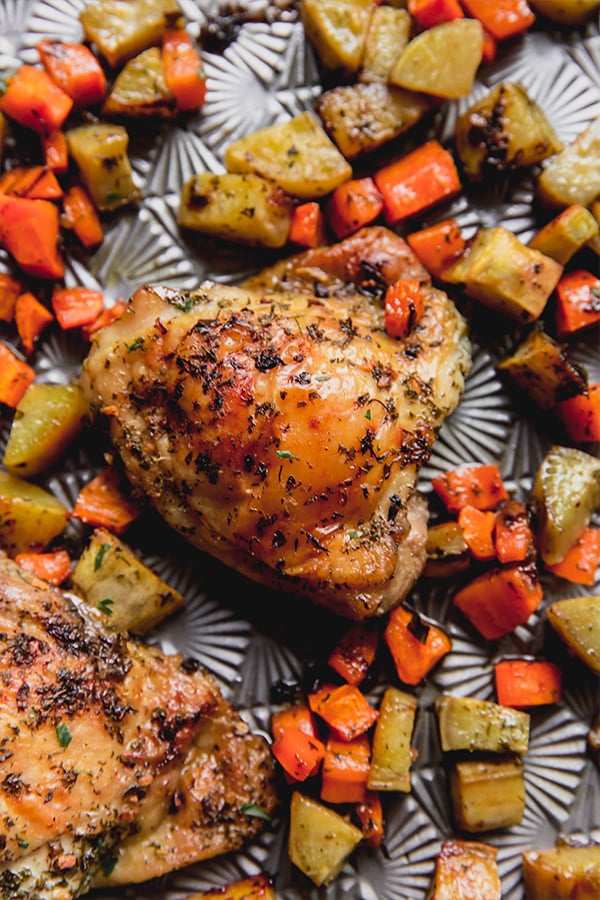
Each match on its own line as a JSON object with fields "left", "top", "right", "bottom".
{"left": 177, "top": 172, "right": 294, "bottom": 247}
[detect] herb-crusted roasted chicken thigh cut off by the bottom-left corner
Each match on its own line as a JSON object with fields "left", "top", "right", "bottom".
{"left": 0, "top": 559, "right": 274, "bottom": 900}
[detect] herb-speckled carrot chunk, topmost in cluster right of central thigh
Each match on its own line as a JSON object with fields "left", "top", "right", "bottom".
{"left": 431, "top": 465, "right": 508, "bottom": 513}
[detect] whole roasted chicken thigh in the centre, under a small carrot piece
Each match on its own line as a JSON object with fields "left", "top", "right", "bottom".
{"left": 82, "top": 228, "right": 469, "bottom": 619}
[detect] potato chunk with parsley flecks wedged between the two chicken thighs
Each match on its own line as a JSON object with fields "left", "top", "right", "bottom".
{"left": 72, "top": 528, "right": 185, "bottom": 634}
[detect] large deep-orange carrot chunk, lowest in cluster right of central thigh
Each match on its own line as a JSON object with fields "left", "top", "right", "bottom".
{"left": 454, "top": 563, "right": 543, "bottom": 640}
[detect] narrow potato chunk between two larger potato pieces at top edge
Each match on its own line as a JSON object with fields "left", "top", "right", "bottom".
{"left": 359, "top": 6, "right": 412, "bottom": 82}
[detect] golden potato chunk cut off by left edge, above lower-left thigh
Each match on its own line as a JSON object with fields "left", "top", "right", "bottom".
{"left": 0, "top": 472, "right": 68, "bottom": 556}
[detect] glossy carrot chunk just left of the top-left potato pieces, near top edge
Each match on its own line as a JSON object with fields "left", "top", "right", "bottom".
{"left": 37, "top": 38, "right": 106, "bottom": 106}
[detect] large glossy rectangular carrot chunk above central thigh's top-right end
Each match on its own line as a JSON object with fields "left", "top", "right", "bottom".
{"left": 373, "top": 141, "right": 461, "bottom": 225}
